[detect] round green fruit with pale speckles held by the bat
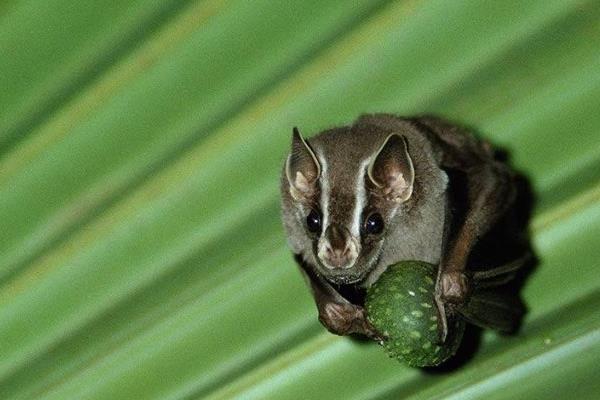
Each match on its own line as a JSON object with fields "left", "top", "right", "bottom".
{"left": 365, "top": 261, "right": 465, "bottom": 367}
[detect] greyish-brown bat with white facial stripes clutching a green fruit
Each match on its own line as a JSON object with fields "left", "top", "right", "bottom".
{"left": 280, "top": 114, "right": 529, "bottom": 342}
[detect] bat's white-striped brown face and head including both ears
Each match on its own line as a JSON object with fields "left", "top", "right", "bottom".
{"left": 282, "top": 128, "right": 414, "bottom": 284}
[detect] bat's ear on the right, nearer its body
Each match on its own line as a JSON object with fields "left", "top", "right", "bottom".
{"left": 368, "top": 133, "right": 415, "bottom": 203}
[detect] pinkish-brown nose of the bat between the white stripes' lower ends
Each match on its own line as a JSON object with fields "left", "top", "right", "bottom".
{"left": 318, "top": 225, "right": 358, "bottom": 269}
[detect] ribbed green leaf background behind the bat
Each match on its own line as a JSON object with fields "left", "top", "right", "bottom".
{"left": 0, "top": 0, "right": 600, "bottom": 399}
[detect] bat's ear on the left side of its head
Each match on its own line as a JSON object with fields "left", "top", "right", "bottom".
{"left": 285, "top": 127, "right": 321, "bottom": 200}
